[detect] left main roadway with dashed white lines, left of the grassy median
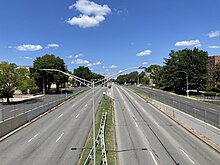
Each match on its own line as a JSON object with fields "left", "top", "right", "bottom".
{"left": 0, "top": 88, "right": 104, "bottom": 165}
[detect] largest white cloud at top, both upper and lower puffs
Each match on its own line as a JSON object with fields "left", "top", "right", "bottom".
{"left": 66, "top": 0, "right": 111, "bottom": 28}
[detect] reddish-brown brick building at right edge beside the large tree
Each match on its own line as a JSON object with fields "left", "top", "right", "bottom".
{"left": 207, "top": 56, "right": 220, "bottom": 87}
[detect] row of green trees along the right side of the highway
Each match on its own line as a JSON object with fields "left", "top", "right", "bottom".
{"left": 116, "top": 48, "right": 220, "bottom": 92}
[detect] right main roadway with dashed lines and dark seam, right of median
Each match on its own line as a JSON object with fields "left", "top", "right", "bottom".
{"left": 112, "top": 85, "right": 220, "bottom": 165}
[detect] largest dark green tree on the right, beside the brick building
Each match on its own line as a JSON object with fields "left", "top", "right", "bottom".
{"left": 160, "top": 48, "right": 208, "bottom": 91}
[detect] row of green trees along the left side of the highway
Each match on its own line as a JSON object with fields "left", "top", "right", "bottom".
{"left": 0, "top": 54, "right": 104, "bottom": 103}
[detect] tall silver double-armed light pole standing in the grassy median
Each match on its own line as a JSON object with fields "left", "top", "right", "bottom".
{"left": 40, "top": 67, "right": 144, "bottom": 165}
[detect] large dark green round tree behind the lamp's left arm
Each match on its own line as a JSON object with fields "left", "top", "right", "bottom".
{"left": 33, "top": 54, "right": 68, "bottom": 92}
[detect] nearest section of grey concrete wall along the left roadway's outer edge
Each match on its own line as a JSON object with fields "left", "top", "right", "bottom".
{"left": 0, "top": 114, "right": 27, "bottom": 137}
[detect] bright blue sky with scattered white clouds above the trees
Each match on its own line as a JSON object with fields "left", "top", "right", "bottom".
{"left": 0, "top": 0, "right": 220, "bottom": 74}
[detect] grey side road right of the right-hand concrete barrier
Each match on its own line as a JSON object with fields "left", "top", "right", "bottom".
{"left": 131, "top": 86, "right": 220, "bottom": 127}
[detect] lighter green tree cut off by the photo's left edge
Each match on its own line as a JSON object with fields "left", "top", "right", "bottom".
{"left": 0, "top": 62, "right": 18, "bottom": 103}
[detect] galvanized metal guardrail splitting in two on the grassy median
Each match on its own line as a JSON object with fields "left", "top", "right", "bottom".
{"left": 84, "top": 112, "right": 108, "bottom": 165}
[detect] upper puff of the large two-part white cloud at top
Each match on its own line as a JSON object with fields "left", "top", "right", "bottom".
{"left": 69, "top": 0, "right": 111, "bottom": 16}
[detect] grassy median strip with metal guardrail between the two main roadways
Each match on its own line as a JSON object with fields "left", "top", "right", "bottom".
{"left": 78, "top": 96, "right": 116, "bottom": 165}
